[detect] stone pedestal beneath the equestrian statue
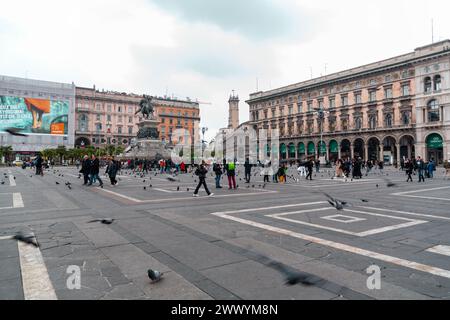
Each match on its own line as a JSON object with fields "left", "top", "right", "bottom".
{"left": 120, "top": 119, "right": 171, "bottom": 160}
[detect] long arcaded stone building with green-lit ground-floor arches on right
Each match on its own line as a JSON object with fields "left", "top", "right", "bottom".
{"left": 247, "top": 40, "right": 450, "bottom": 164}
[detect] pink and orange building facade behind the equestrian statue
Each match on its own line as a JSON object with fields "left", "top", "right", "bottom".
{"left": 75, "top": 86, "right": 200, "bottom": 147}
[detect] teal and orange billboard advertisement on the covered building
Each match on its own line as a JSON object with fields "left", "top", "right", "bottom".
{"left": 0, "top": 96, "right": 69, "bottom": 135}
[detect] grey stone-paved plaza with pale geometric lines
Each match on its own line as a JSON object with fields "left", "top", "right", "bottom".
{"left": 0, "top": 167, "right": 450, "bottom": 300}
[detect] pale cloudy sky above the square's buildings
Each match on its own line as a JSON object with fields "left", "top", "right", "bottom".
{"left": 0, "top": 0, "right": 450, "bottom": 137}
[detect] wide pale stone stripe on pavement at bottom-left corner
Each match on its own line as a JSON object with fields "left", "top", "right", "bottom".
{"left": 18, "top": 242, "right": 57, "bottom": 300}
